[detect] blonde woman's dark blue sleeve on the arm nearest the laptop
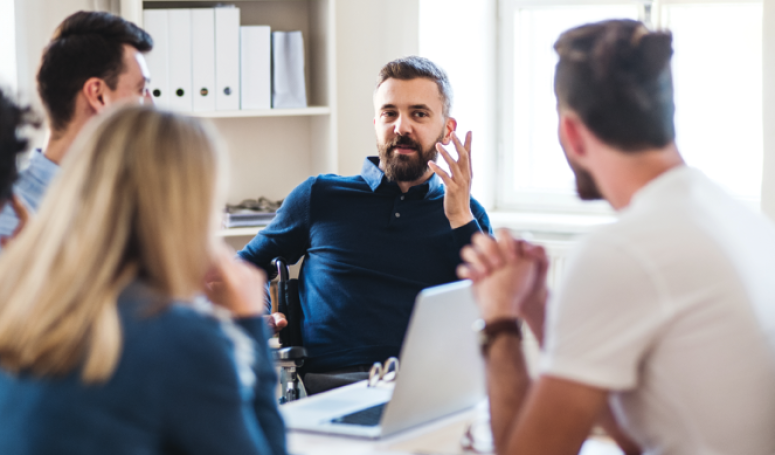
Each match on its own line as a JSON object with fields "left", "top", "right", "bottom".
{"left": 161, "top": 320, "right": 286, "bottom": 455}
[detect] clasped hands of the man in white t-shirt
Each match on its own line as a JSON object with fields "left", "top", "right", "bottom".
{"left": 458, "top": 230, "right": 548, "bottom": 328}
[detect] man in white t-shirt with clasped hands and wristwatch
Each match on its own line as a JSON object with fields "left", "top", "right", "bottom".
{"left": 459, "top": 21, "right": 775, "bottom": 455}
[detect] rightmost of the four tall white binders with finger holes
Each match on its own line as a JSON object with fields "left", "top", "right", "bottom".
{"left": 215, "top": 7, "right": 240, "bottom": 111}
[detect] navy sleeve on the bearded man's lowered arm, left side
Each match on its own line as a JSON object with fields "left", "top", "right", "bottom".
{"left": 237, "top": 178, "right": 315, "bottom": 276}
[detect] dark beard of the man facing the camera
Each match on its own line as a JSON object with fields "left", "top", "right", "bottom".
{"left": 377, "top": 130, "right": 444, "bottom": 182}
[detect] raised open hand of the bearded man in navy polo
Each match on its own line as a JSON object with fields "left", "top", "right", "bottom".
{"left": 428, "top": 131, "right": 474, "bottom": 229}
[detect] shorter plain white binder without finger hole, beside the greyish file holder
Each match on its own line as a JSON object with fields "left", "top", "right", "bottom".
{"left": 240, "top": 25, "right": 272, "bottom": 109}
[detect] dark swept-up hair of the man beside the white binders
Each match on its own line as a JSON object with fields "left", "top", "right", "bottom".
{"left": 38, "top": 11, "right": 153, "bottom": 130}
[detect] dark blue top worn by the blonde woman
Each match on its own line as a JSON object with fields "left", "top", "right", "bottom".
{"left": 0, "top": 283, "right": 286, "bottom": 455}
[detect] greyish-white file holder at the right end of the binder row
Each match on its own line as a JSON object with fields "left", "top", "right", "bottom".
{"left": 272, "top": 31, "right": 307, "bottom": 109}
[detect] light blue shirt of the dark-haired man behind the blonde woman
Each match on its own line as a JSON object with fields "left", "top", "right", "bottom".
{"left": 0, "top": 149, "right": 59, "bottom": 236}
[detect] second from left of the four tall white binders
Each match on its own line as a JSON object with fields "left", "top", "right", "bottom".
{"left": 168, "top": 9, "right": 193, "bottom": 111}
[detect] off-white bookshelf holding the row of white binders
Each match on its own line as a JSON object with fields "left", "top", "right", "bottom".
{"left": 120, "top": 0, "right": 338, "bottom": 210}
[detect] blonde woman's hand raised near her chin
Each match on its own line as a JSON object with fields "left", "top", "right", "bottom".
{"left": 205, "top": 246, "right": 268, "bottom": 319}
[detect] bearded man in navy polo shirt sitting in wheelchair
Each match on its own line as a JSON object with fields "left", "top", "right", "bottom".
{"left": 239, "top": 57, "right": 490, "bottom": 393}
